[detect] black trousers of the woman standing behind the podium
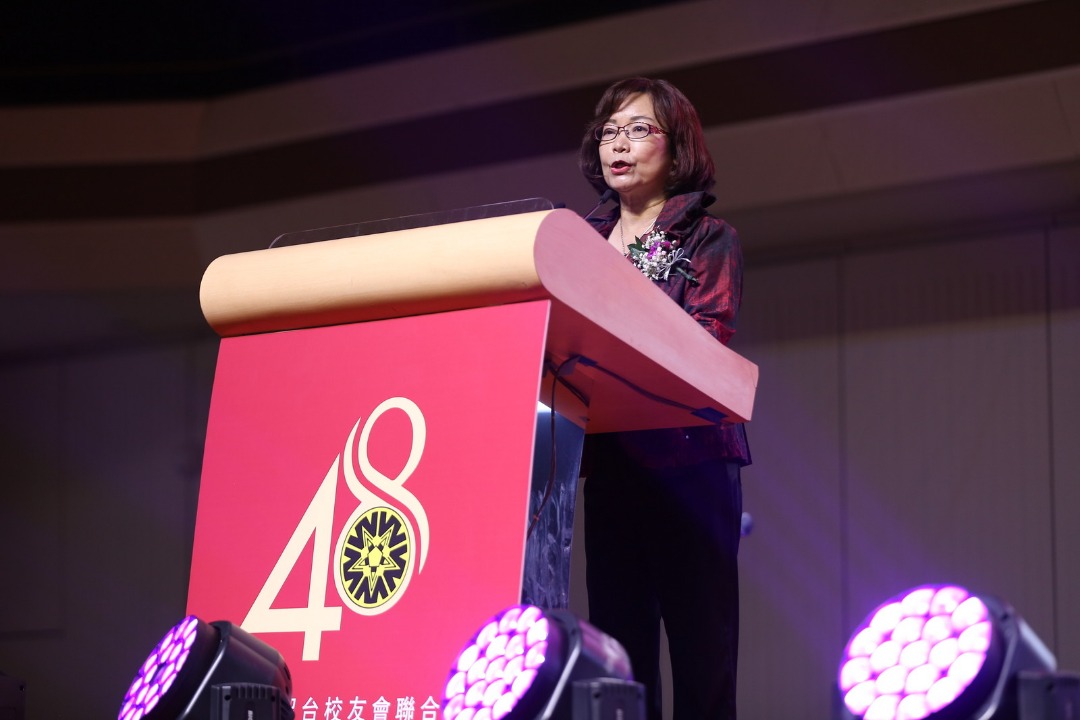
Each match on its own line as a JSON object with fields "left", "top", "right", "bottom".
{"left": 584, "top": 443, "right": 742, "bottom": 720}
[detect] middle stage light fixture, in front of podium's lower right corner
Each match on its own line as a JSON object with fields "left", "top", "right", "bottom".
{"left": 442, "top": 604, "right": 645, "bottom": 720}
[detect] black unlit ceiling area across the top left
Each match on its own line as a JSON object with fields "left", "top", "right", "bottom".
{"left": 0, "top": 0, "right": 691, "bottom": 106}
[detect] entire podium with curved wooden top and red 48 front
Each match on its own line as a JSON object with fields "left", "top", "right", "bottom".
{"left": 188, "top": 202, "right": 757, "bottom": 720}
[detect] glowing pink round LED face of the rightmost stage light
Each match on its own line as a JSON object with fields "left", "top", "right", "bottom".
{"left": 837, "top": 585, "right": 993, "bottom": 720}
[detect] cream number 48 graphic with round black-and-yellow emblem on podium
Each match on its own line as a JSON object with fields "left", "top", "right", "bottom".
{"left": 241, "top": 397, "right": 428, "bottom": 661}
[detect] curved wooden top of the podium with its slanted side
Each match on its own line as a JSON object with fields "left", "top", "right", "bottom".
{"left": 201, "top": 209, "right": 758, "bottom": 432}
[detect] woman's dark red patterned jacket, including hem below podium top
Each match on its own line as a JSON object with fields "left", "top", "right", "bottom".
{"left": 589, "top": 192, "right": 751, "bottom": 467}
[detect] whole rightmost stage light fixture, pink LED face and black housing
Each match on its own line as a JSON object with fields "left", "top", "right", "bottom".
{"left": 837, "top": 585, "right": 1056, "bottom": 720}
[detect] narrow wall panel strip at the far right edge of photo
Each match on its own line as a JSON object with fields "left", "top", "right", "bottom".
{"left": 1043, "top": 227, "right": 1080, "bottom": 673}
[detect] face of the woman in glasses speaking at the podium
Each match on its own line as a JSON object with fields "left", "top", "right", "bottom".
{"left": 599, "top": 93, "right": 672, "bottom": 204}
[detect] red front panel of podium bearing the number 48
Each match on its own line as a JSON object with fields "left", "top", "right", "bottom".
{"left": 188, "top": 300, "right": 551, "bottom": 720}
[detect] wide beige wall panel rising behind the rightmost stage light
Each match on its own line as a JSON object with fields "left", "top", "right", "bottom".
{"left": 843, "top": 233, "right": 1054, "bottom": 636}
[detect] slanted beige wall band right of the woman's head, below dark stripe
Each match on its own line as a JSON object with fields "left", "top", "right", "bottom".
{"left": 706, "top": 69, "right": 1080, "bottom": 237}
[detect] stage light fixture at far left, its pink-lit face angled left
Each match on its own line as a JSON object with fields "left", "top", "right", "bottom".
{"left": 118, "top": 615, "right": 294, "bottom": 720}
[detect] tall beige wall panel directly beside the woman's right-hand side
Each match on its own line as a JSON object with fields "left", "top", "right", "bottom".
{"left": 732, "top": 260, "right": 845, "bottom": 720}
